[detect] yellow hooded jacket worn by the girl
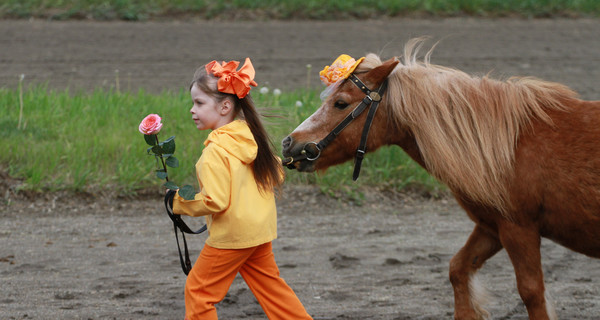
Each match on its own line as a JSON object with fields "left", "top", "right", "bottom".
{"left": 173, "top": 120, "right": 277, "bottom": 249}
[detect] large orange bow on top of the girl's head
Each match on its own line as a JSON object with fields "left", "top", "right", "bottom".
{"left": 206, "top": 58, "right": 257, "bottom": 99}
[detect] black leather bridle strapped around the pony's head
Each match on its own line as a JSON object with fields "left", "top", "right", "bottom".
{"left": 282, "top": 73, "right": 387, "bottom": 181}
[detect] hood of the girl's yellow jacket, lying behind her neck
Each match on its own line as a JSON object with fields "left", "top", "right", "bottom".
{"left": 204, "top": 120, "right": 258, "bottom": 163}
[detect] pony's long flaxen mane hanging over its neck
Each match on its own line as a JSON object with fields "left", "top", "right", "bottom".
{"left": 357, "top": 38, "right": 577, "bottom": 213}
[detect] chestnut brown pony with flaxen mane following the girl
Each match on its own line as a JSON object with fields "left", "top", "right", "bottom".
{"left": 282, "top": 38, "right": 600, "bottom": 320}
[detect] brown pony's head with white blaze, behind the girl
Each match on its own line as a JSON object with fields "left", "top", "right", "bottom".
{"left": 282, "top": 54, "right": 399, "bottom": 172}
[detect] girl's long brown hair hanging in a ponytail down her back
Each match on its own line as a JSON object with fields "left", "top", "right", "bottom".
{"left": 190, "top": 70, "right": 284, "bottom": 192}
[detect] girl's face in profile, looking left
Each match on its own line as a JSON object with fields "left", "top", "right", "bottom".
{"left": 190, "top": 84, "right": 231, "bottom": 130}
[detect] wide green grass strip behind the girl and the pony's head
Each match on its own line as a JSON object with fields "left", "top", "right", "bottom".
{"left": 0, "top": 86, "right": 443, "bottom": 198}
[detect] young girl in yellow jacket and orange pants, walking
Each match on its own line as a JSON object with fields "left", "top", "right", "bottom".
{"left": 168, "top": 58, "right": 312, "bottom": 320}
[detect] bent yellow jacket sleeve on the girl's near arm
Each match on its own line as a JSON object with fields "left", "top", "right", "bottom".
{"left": 173, "top": 147, "right": 231, "bottom": 217}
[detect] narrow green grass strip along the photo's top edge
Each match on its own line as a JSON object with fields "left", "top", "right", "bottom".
{"left": 0, "top": 0, "right": 600, "bottom": 20}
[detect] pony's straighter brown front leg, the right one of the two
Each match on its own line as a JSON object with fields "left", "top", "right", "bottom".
{"left": 499, "top": 221, "right": 556, "bottom": 320}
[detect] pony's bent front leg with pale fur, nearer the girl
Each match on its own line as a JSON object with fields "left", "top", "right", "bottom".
{"left": 450, "top": 225, "right": 502, "bottom": 320}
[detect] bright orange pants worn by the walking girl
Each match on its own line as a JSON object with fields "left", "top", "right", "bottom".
{"left": 185, "top": 242, "right": 312, "bottom": 320}
